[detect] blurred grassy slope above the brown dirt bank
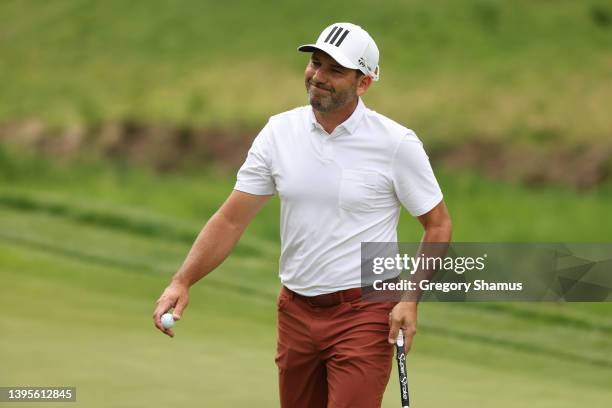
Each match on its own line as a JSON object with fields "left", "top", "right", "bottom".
{"left": 0, "top": 0, "right": 612, "bottom": 144}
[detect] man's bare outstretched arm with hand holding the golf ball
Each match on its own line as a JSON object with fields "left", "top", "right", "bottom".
{"left": 153, "top": 190, "right": 272, "bottom": 337}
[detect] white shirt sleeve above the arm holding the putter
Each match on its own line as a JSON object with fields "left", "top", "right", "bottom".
{"left": 391, "top": 132, "right": 442, "bottom": 217}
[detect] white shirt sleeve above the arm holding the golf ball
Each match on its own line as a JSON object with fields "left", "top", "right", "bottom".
{"left": 234, "top": 122, "right": 276, "bottom": 195}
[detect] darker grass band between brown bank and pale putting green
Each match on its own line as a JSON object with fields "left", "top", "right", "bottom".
{"left": 0, "top": 149, "right": 612, "bottom": 242}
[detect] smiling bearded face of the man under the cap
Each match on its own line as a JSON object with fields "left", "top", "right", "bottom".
{"left": 304, "top": 51, "right": 367, "bottom": 113}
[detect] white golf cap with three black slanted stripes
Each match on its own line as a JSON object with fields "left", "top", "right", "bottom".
{"left": 298, "top": 23, "right": 380, "bottom": 81}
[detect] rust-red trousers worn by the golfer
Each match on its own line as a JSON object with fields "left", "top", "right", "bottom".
{"left": 275, "top": 287, "right": 395, "bottom": 408}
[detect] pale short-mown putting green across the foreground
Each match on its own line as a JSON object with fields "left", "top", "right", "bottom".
{"left": 0, "top": 236, "right": 612, "bottom": 407}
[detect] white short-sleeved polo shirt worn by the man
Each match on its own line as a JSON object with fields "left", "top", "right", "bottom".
{"left": 235, "top": 100, "right": 442, "bottom": 296}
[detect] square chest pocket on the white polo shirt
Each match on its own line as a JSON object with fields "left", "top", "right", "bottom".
{"left": 339, "top": 170, "right": 384, "bottom": 211}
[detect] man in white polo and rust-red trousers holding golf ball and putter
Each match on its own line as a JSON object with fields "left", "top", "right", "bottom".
{"left": 154, "top": 23, "right": 451, "bottom": 408}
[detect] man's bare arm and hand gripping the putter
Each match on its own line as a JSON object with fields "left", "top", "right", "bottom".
{"left": 389, "top": 200, "right": 452, "bottom": 352}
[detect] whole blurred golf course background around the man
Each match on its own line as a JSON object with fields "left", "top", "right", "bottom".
{"left": 0, "top": 0, "right": 612, "bottom": 408}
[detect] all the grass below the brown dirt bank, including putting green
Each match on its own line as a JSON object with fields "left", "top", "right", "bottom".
{"left": 0, "top": 159, "right": 612, "bottom": 407}
